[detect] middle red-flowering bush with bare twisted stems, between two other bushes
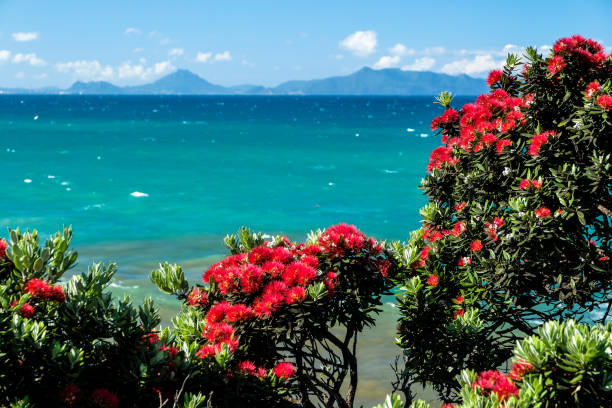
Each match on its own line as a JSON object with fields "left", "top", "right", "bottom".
{"left": 151, "top": 224, "right": 397, "bottom": 407}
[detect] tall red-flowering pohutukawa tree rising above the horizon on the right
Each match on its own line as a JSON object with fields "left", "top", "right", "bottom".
{"left": 396, "top": 36, "right": 612, "bottom": 401}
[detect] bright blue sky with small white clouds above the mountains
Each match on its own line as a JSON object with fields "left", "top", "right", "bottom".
{"left": 0, "top": 0, "right": 612, "bottom": 88}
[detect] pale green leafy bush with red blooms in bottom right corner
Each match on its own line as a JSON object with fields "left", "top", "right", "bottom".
{"left": 390, "top": 320, "right": 612, "bottom": 408}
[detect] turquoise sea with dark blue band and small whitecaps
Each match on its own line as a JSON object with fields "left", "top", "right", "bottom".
{"left": 0, "top": 95, "right": 474, "bottom": 407}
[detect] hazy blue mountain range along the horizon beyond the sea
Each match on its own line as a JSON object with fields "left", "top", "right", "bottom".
{"left": 0, "top": 67, "right": 487, "bottom": 95}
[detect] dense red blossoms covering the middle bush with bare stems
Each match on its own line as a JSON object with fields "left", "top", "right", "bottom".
{"left": 196, "top": 224, "right": 392, "bottom": 379}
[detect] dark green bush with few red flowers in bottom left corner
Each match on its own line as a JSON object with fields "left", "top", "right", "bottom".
{"left": 0, "top": 228, "right": 204, "bottom": 408}
